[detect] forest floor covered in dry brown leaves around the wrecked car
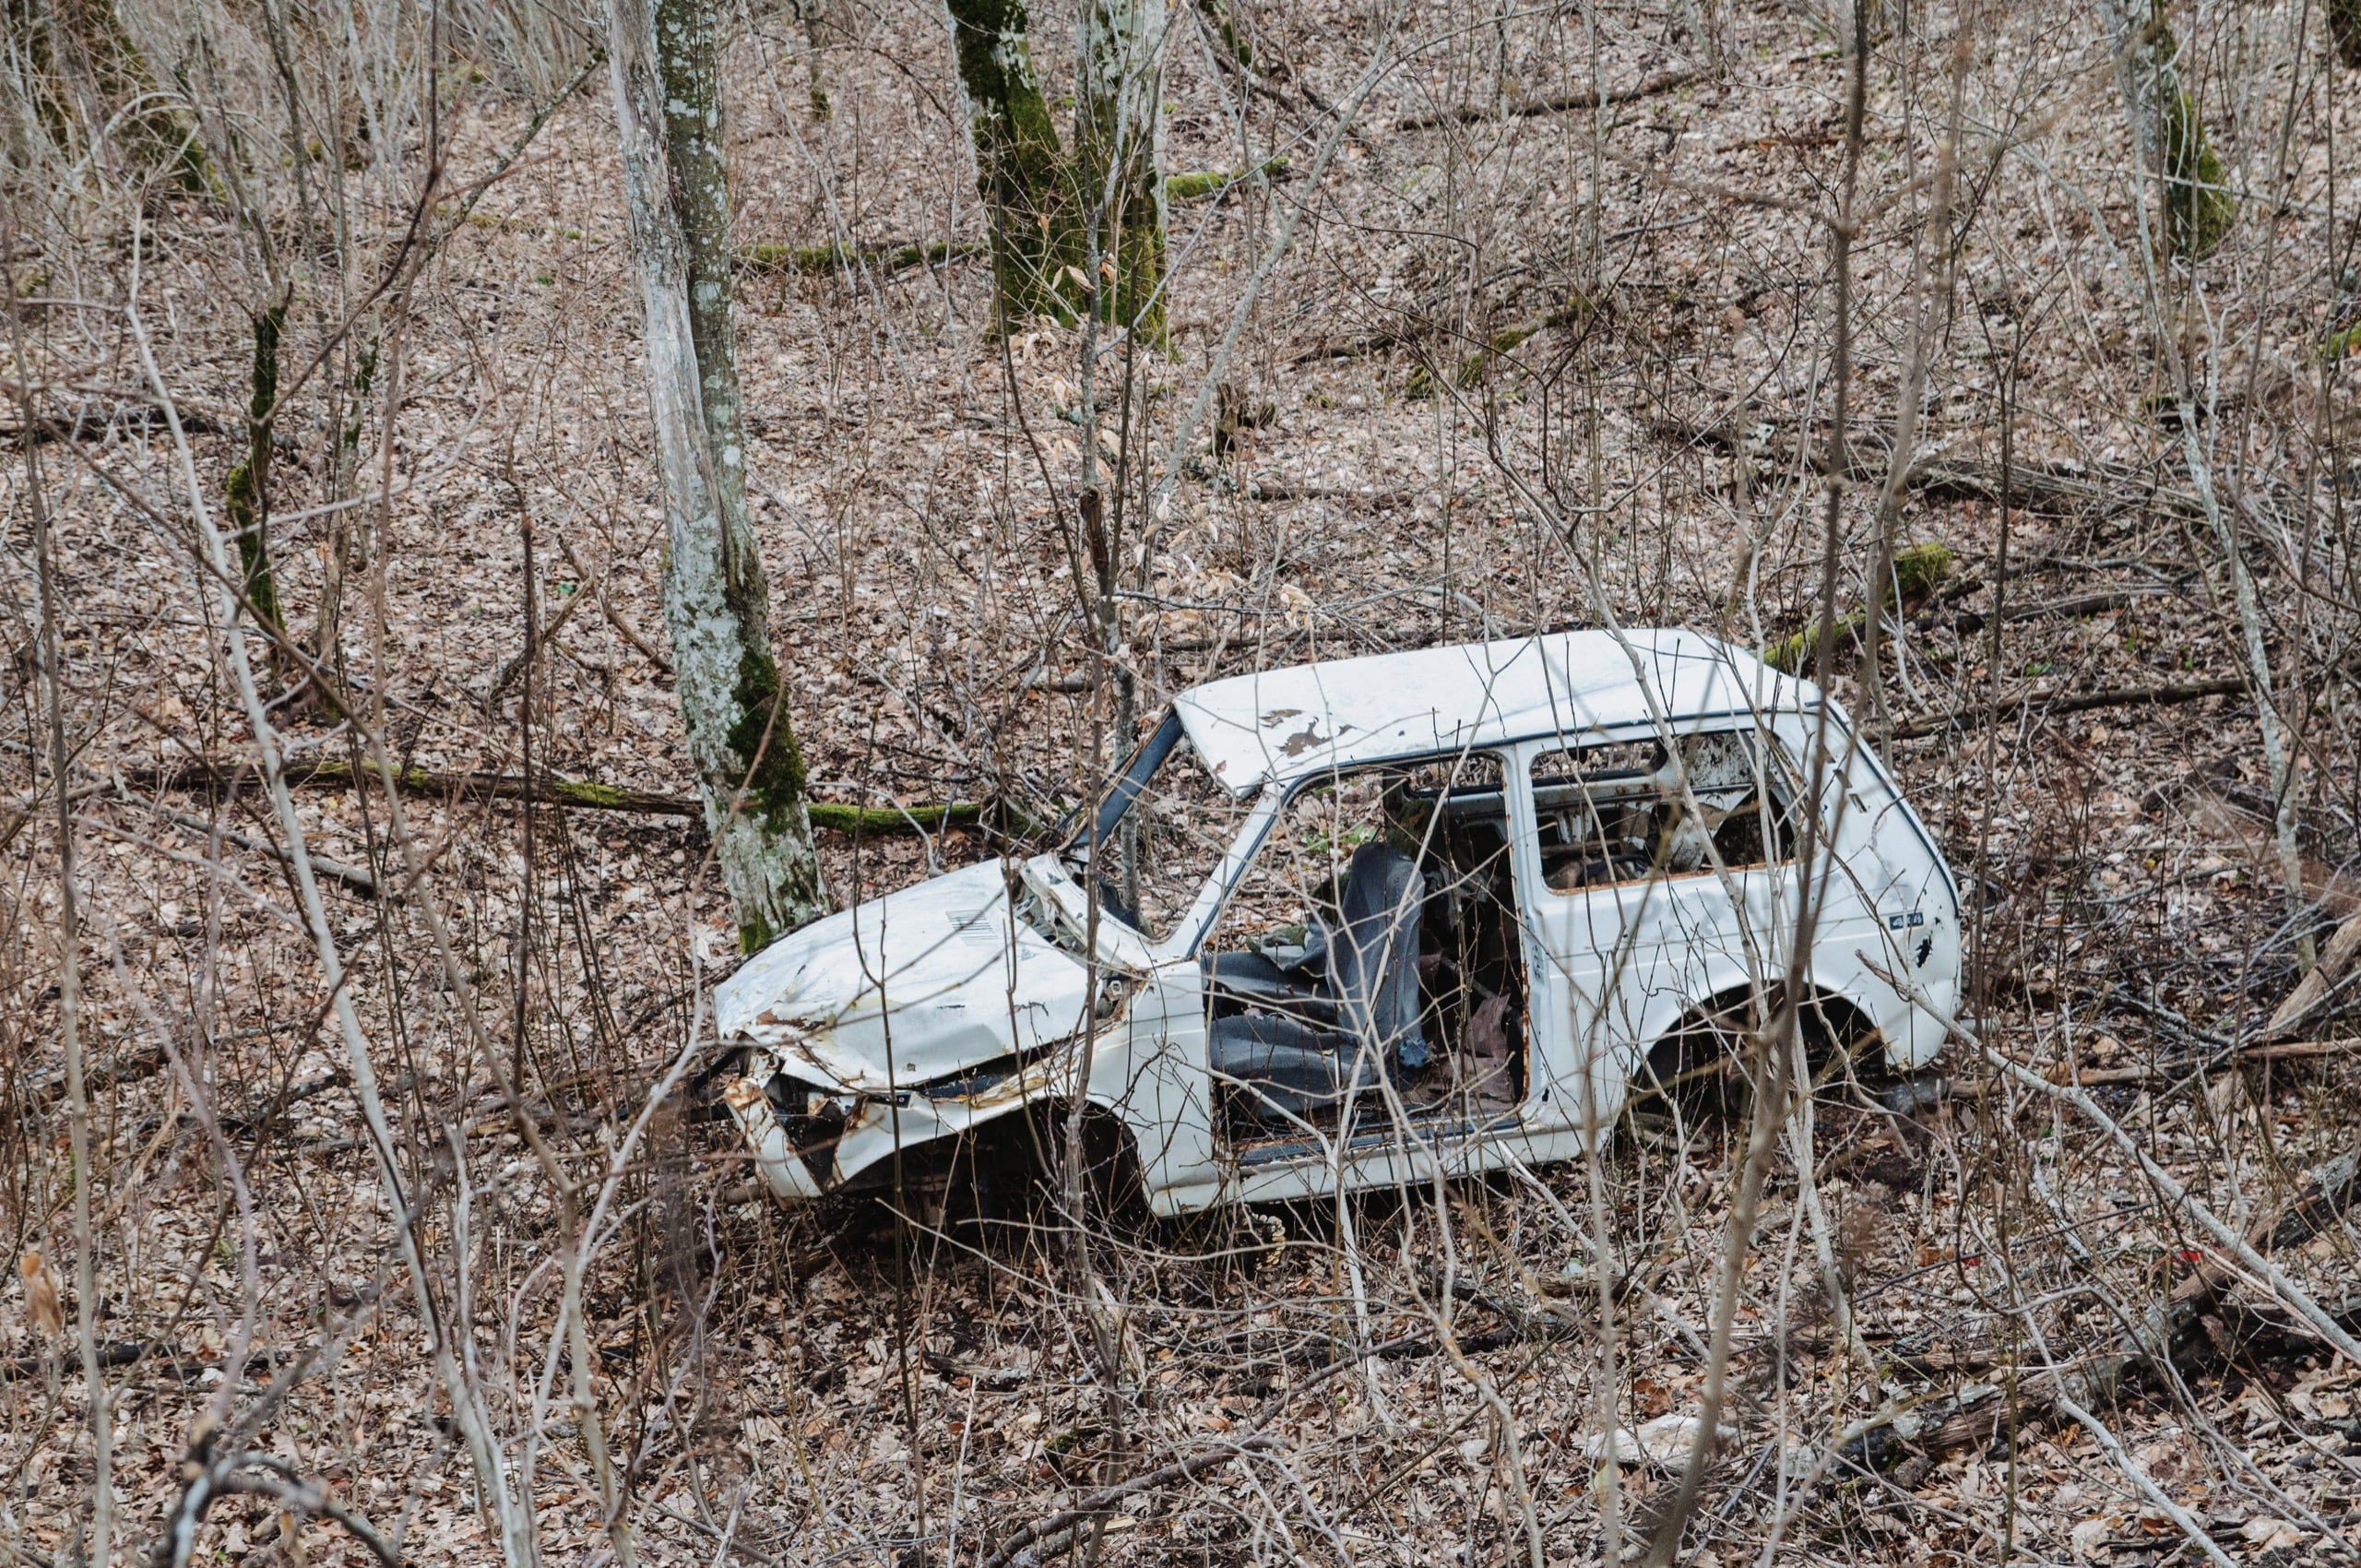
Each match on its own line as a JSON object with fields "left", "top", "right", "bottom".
{"left": 0, "top": 3, "right": 2361, "bottom": 1568}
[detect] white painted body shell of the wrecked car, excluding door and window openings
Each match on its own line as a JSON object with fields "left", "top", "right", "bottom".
{"left": 716, "top": 631, "right": 1960, "bottom": 1214}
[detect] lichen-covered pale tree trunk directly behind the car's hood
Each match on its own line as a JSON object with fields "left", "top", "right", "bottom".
{"left": 607, "top": 0, "right": 826, "bottom": 952}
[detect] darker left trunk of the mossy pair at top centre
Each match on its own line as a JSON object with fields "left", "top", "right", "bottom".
{"left": 947, "top": 0, "right": 1086, "bottom": 328}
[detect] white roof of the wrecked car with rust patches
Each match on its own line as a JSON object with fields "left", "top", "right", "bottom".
{"left": 1173, "top": 631, "right": 1818, "bottom": 796}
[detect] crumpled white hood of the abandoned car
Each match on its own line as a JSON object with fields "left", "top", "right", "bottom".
{"left": 713, "top": 861, "right": 1088, "bottom": 1093}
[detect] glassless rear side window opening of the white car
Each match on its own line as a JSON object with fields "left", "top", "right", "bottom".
{"left": 1532, "top": 730, "right": 1797, "bottom": 893}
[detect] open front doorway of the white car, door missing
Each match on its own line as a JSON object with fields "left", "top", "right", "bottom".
{"left": 1202, "top": 754, "right": 1525, "bottom": 1135}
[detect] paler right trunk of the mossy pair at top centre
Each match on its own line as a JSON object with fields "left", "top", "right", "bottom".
{"left": 1074, "top": 0, "right": 1164, "bottom": 340}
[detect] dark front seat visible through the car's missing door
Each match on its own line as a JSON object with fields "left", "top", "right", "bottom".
{"left": 1206, "top": 840, "right": 1426, "bottom": 1120}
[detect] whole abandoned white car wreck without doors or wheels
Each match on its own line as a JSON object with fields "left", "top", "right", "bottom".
{"left": 716, "top": 631, "right": 1960, "bottom": 1214}
